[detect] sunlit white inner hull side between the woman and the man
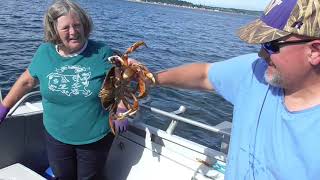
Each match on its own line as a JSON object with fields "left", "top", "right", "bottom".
{"left": 106, "top": 122, "right": 225, "bottom": 180}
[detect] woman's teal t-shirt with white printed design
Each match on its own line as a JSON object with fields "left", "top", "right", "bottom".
{"left": 29, "top": 40, "right": 112, "bottom": 145}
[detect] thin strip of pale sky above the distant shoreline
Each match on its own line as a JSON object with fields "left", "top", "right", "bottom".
{"left": 184, "top": 0, "right": 270, "bottom": 11}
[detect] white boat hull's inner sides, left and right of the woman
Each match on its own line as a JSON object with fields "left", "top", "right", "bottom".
{"left": 0, "top": 92, "right": 230, "bottom": 180}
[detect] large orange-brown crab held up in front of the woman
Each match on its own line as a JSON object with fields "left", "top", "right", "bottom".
{"left": 99, "top": 41, "right": 155, "bottom": 133}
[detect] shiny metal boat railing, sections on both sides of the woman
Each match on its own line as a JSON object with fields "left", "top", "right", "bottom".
{"left": 7, "top": 91, "right": 230, "bottom": 137}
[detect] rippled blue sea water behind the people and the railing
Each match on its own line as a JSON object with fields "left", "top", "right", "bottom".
{"left": 0, "top": 0, "right": 258, "bottom": 148}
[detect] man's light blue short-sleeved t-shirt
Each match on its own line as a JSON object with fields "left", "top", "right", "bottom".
{"left": 209, "top": 54, "right": 320, "bottom": 180}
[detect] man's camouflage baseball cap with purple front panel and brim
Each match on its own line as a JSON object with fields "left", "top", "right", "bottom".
{"left": 238, "top": 0, "right": 320, "bottom": 44}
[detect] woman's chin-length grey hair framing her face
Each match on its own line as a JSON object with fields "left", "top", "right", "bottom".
{"left": 43, "top": 0, "right": 93, "bottom": 44}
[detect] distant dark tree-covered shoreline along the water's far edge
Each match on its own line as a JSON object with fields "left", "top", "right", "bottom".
{"left": 126, "top": 0, "right": 260, "bottom": 16}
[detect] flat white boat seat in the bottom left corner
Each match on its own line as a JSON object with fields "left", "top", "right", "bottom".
{"left": 0, "top": 163, "right": 46, "bottom": 180}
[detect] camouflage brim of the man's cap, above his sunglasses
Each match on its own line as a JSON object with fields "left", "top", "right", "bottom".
{"left": 237, "top": 19, "right": 291, "bottom": 44}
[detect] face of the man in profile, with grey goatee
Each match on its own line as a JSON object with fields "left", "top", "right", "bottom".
{"left": 259, "top": 36, "right": 310, "bottom": 88}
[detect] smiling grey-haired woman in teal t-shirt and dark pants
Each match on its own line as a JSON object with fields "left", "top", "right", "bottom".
{"left": 0, "top": 0, "right": 127, "bottom": 180}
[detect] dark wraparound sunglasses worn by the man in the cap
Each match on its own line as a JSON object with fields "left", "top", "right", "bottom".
{"left": 261, "top": 39, "right": 314, "bottom": 55}
